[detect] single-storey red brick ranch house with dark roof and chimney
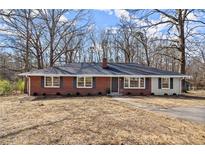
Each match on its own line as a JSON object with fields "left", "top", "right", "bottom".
{"left": 20, "top": 58, "right": 188, "bottom": 95}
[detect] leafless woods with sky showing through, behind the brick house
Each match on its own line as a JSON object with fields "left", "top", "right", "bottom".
{"left": 0, "top": 9, "right": 205, "bottom": 88}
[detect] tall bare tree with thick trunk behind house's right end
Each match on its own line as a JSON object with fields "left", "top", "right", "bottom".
{"left": 129, "top": 9, "right": 205, "bottom": 90}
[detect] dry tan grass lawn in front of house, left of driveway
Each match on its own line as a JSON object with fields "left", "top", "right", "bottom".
{"left": 0, "top": 96, "right": 205, "bottom": 144}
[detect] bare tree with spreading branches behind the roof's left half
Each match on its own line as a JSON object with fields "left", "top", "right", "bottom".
{"left": 39, "top": 10, "right": 89, "bottom": 66}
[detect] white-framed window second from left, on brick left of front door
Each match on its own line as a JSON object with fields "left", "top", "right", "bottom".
{"left": 77, "top": 77, "right": 93, "bottom": 88}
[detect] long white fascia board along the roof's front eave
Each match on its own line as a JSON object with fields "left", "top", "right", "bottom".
{"left": 19, "top": 73, "right": 191, "bottom": 78}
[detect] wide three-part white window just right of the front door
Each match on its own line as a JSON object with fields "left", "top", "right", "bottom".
{"left": 124, "top": 77, "right": 145, "bottom": 89}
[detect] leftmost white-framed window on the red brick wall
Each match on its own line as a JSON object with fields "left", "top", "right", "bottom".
{"left": 44, "top": 76, "right": 60, "bottom": 87}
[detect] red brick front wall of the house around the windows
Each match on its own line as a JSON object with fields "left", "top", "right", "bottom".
{"left": 30, "top": 76, "right": 151, "bottom": 95}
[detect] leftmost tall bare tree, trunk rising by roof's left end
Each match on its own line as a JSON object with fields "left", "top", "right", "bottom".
{"left": 0, "top": 10, "right": 32, "bottom": 71}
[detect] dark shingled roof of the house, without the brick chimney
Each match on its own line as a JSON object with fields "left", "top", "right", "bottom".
{"left": 19, "top": 63, "right": 188, "bottom": 77}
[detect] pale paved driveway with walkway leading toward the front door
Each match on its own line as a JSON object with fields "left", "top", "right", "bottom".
{"left": 113, "top": 97, "right": 205, "bottom": 123}
